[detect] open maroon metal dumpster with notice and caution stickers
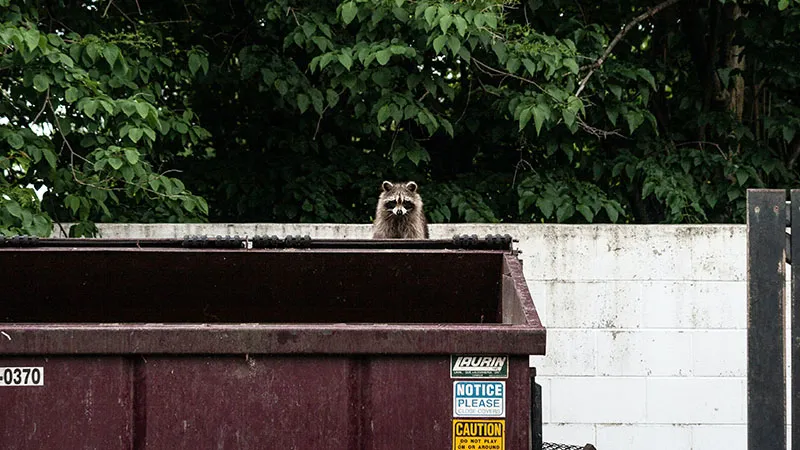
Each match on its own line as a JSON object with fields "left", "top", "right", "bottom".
{"left": 0, "top": 236, "right": 545, "bottom": 450}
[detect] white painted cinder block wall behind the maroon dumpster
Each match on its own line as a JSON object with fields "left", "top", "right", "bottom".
{"left": 51, "top": 224, "right": 776, "bottom": 450}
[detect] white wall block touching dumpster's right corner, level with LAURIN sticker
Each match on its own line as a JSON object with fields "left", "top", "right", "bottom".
{"left": 530, "top": 328, "right": 597, "bottom": 376}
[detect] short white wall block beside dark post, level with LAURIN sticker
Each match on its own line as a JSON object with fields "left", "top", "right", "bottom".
{"left": 691, "top": 330, "right": 747, "bottom": 377}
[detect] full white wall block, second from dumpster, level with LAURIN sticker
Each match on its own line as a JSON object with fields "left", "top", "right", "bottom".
{"left": 597, "top": 330, "right": 692, "bottom": 376}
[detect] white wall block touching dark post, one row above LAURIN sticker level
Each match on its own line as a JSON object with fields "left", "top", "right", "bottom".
{"left": 641, "top": 281, "right": 747, "bottom": 329}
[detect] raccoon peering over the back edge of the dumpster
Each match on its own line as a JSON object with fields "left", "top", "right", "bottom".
{"left": 372, "top": 181, "right": 428, "bottom": 239}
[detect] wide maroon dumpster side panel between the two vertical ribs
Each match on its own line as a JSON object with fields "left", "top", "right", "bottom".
{"left": 137, "top": 355, "right": 358, "bottom": 450}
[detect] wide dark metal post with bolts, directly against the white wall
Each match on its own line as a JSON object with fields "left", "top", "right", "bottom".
{"left": 747, "top": 189, "right": 786, "bottom": 450}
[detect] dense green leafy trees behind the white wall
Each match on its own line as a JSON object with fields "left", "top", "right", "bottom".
{"left": 0, "top": 0, "right": 800, "bottom": 235}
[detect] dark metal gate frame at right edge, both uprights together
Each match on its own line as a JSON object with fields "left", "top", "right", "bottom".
{"left": 747, "top": 189, "right": 800, "bottom": 450}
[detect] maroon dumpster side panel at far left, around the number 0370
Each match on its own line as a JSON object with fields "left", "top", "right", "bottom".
{"left": 0, "top": 356, "right": 133, "bottom": 450}
